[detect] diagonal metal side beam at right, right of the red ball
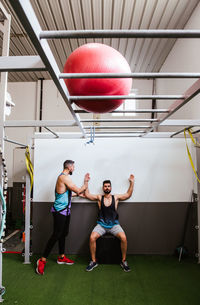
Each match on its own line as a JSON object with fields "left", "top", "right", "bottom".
{"left": 143, "top": 79, "right": 200, "bottom": 133}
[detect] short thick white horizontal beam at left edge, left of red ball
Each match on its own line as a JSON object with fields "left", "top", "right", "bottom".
{"left": 0, "top": 56, "right": 47, "bottom": 72}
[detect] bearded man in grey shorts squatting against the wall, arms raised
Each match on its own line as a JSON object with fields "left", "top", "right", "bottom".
{"left": 84, "top": 175, "right": 134, "bottom": 272}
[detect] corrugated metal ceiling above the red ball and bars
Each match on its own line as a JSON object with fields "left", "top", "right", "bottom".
{"left": 0, "top": 0, "right": 199, "bottom": 81}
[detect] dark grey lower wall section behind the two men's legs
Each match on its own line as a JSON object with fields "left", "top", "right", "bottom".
{"left": 32, "top": 202, "right": 197, "bottom": 254}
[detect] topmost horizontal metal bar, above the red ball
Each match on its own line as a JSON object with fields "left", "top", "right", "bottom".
{"left": 39, "top": 29, "right": 200, "bottom": 39}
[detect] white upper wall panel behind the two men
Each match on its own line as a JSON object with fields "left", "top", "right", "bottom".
{"left": 34, "top": 138, "right": 193, "bottom": 202}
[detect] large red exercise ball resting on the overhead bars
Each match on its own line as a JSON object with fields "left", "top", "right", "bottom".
{"left": 64, "top": 43, "right": 132, "bottom": 113}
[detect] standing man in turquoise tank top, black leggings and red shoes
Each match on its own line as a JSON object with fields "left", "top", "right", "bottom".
{"left": 36, "top": 160, "right": 89, "bottom": 275}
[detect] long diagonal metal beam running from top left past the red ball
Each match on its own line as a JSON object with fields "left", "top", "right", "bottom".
{"left": 9, "top": 0, "right": 85, "bottom": 135}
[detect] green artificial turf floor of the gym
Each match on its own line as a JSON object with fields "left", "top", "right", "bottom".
{"left": 3, "top": 254, "right": 200, "bottom": 305}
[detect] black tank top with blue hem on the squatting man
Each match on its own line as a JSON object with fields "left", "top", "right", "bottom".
{"left": 97, "top": 195, "right": 119, "bottom": 228}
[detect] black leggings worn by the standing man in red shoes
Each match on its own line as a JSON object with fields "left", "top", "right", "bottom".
{"left": 42, "top": 212, "right": 70, "bottom": 258}
